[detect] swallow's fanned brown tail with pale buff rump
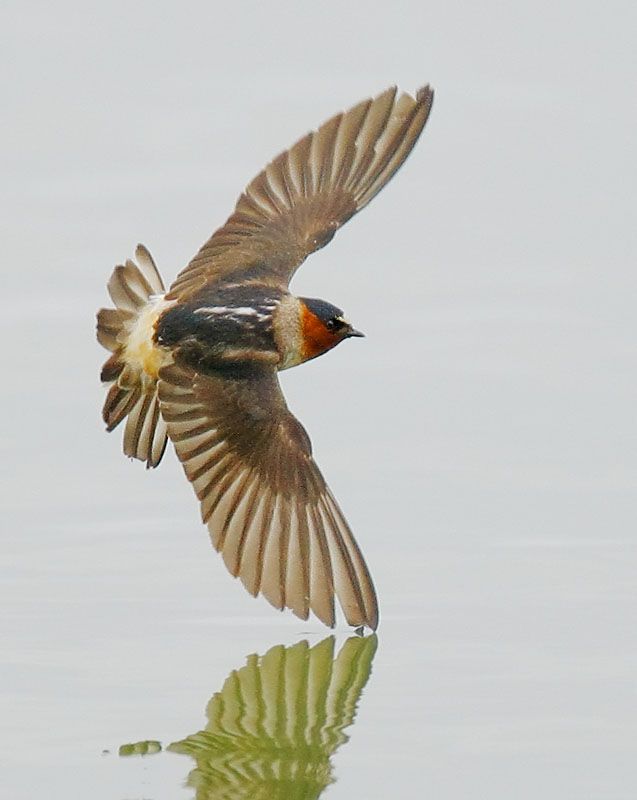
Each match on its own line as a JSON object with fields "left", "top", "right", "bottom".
{"left": 97, "top": 245, "right": 170, "bottom": 467}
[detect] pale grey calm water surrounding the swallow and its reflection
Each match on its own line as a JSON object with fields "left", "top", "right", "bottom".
{"left": 0, "top": 0, "right": 637, "bottom": 800}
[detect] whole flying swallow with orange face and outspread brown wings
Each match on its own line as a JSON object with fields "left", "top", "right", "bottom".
{"left": 97, "top": 85, "right": 433, "bottom": 630}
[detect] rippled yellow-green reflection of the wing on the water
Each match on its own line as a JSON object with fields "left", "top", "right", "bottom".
{"left": 120, "top": 636, "right": 377, "bottom": 800}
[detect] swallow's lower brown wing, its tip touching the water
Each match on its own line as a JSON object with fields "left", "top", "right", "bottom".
{"left": 159, "top": 364, "right": 378, "bottom": 629}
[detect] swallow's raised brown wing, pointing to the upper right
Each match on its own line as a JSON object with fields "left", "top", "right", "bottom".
{"left": 168, "top": 86, "right": 433, "bottom": 299}
